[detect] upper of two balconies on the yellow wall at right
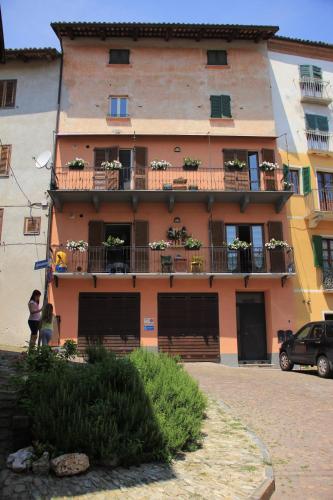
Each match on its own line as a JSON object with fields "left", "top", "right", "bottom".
{"left": 306, "top": 188, "right": 333, "bottom": 228}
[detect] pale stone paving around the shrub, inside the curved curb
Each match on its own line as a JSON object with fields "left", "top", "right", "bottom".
{"left": 0, "top": 402, "right": 265, "bottom": 500}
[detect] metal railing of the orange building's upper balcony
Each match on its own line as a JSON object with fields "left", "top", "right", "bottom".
{"left": 53, "top": 166, "right": 284, "bottom": 191}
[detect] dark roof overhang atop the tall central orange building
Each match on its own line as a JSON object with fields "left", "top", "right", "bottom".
{"left": 51, "top": 22, "right": 279, "bottom": 42}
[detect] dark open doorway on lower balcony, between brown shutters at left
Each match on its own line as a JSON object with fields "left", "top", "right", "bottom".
{"left": 105, "top": 223, "right": 132, "bottom": 273}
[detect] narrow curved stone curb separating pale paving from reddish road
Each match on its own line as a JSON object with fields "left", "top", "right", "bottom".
{"left": 215, "top": 400, "right": 275, "bottom": 500}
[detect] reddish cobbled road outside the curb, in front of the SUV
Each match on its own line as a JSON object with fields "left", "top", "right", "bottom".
{"left": 186, "top": 363, "right": 333, "bottom": 500}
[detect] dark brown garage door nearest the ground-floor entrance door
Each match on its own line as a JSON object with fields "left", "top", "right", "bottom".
{"left": 158, "top": 293, "right": 220, "bottom": 361}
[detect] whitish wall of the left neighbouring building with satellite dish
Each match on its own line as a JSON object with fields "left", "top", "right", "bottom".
{"left": 0, "top": 59, "right": 60, "bottom": 345}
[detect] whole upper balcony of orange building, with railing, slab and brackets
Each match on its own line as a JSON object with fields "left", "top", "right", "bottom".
{"left": 50, "top": 167, "right": 292, "bottom": 212}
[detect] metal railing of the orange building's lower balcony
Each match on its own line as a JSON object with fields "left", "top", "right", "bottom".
{"left": 52, "top": 246, "right": 295, "bottom": 274}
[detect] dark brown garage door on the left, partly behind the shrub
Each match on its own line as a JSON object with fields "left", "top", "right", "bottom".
{"left": 78, "top": 293, "right": 140, "bottom": 354}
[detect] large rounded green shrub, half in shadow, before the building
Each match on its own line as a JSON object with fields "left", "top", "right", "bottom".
{"left": 23, "top": 350, "right": 205, "bottom": 465}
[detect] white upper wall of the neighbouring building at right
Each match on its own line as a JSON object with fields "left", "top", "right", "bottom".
{"left": 268, "top": 51, "right": 333, "bottom": 153}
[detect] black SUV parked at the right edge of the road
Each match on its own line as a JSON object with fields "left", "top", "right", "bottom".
{"left": 280, "top": 321, "right": 333, "bottom": 378}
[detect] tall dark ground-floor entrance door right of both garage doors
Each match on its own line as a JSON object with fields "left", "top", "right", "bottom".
{"left": 236, "top": 292, "right": 267, "bottom": 363}
